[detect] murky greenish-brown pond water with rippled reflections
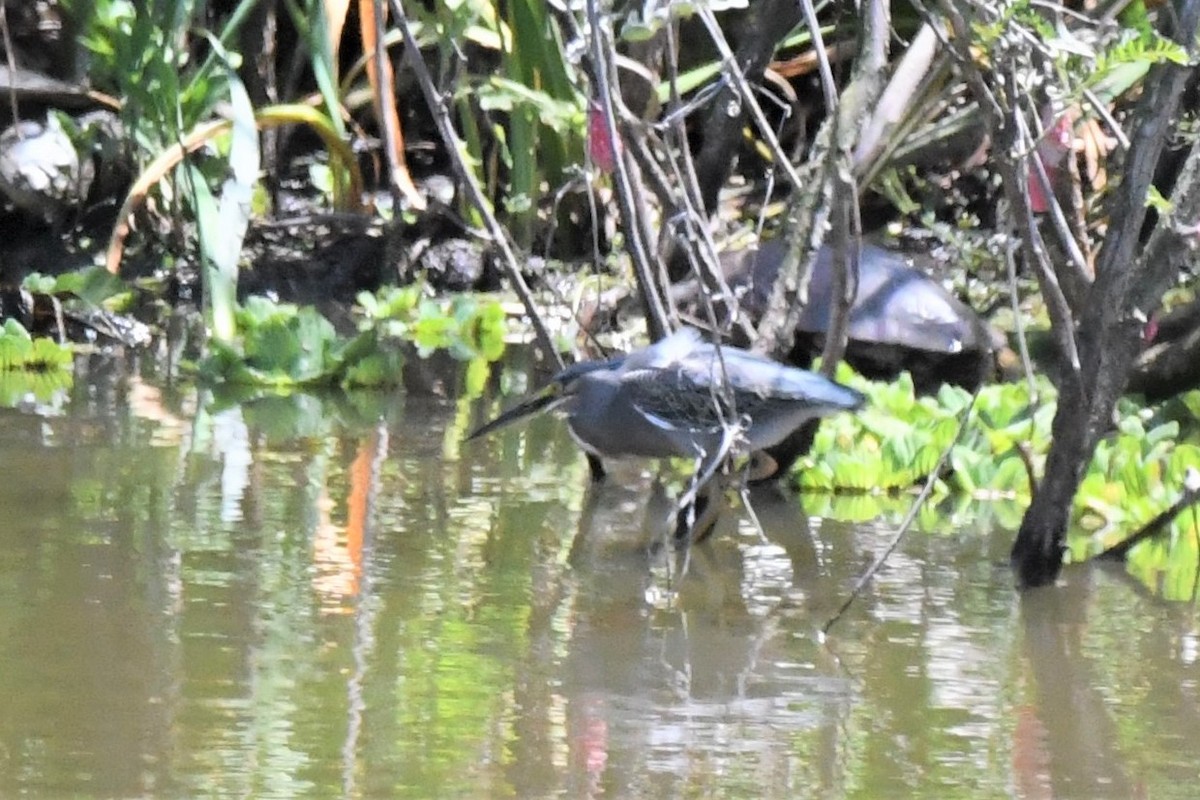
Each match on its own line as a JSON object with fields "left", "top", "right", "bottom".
{"left": 0, "top": 352, "right": 1200, "bottom": 798}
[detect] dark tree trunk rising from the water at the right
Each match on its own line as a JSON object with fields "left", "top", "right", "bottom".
{"left": 1012, "top": 0, "right": 1200, "bottom": 587}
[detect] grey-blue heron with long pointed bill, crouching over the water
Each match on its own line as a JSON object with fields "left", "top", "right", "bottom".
{"left": 467, "top": 327, "right": 864, "bottom": 542}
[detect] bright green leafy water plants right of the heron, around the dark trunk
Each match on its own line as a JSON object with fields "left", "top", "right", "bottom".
{"left": 794, "top": 369, "right": 1200, "bottom": 597}
